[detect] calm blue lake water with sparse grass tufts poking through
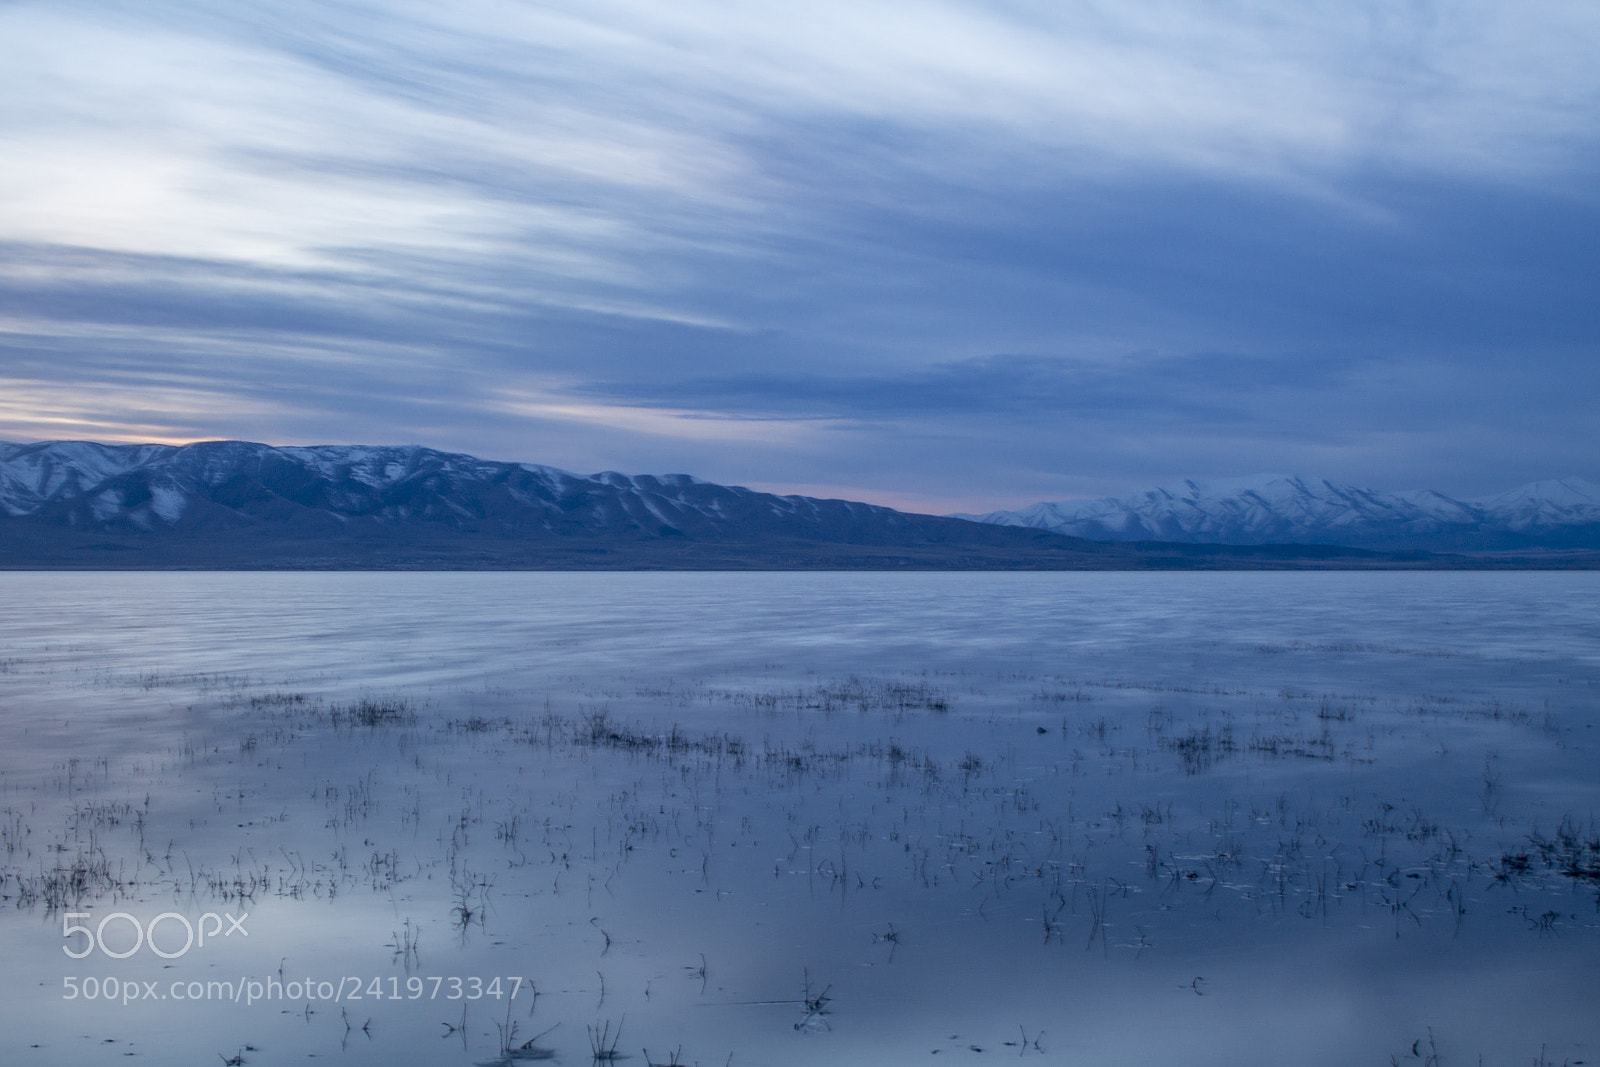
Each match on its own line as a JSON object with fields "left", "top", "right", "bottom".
{"left": 0, "top": 574, "right": 1600, "bottom": 1065}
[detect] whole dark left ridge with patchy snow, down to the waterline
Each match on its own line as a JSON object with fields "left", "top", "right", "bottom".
{"left": 0, "top": 442, "right": 1094, "bottom": 566}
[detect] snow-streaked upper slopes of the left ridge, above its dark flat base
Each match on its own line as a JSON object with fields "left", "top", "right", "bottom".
{"left": 0, "top": 442, "right": 912, "bottom": 536}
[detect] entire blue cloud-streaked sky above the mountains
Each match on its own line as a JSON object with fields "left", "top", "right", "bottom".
{"left": 0, "top": 0, "right": 1600, "bottom": 514}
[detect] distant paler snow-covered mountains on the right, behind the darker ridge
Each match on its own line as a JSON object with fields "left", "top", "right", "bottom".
{"left": 958, "top": 475, "right": 1600, "bottom": 552}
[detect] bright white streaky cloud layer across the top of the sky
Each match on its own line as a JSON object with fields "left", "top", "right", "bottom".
{"left": 12, "top": 0, "right": 1600, "bottom": 275}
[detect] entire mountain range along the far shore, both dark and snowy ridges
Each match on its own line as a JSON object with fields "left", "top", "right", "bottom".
{"left": 0, "top": 442, "right": 1600, "bottom": 569}
